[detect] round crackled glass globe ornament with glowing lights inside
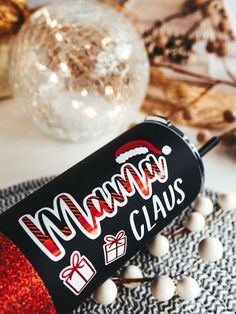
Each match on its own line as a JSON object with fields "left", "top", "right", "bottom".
{"left": 10, "top": 0, "right": 149, "bottom": 141}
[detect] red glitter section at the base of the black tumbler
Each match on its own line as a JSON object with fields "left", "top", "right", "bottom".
{"left": 0, "top": 233, "right": 56, "bottom": 314}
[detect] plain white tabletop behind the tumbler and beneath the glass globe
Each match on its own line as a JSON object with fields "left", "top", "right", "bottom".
{"left": 0, "top": 99, "right": 236, "bottom": 192}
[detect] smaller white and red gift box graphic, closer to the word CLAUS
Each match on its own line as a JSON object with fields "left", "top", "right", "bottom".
{"left": 103, "top": 230, "right": 127, "bottom": 265}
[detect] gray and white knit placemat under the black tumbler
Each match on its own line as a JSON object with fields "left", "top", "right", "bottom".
{"left": 0, "top": 178, "right": 236, "bottom": 314}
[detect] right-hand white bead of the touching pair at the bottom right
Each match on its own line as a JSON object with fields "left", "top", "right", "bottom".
{"left": 176, "top": 277, "right": 200, "bottom": 301}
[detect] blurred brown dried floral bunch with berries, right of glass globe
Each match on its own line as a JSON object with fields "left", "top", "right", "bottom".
{"left": 138, "top": 0, "right": 236, "bottom": 132}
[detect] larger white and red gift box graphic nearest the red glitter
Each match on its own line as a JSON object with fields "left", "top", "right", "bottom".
{"left": 60, "top": 251, "right": 96, "bottom": 295}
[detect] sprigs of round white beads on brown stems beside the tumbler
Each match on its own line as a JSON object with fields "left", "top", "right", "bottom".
{"left": 94, "top": 194, "right": 236, "bottom": 305}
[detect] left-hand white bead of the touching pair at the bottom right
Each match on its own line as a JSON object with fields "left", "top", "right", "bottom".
{"left": 151, "top": 275, "right": 175, "bottom": 302}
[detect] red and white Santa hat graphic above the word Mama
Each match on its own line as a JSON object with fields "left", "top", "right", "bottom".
{"left": 115, "top": 140, "right": 172, "bottom": 164}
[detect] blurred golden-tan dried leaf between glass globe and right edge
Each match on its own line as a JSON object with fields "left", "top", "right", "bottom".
{"left": 141, "top": 66, "right": 236, "bottom": 130}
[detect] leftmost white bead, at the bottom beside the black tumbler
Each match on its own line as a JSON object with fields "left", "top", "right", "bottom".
{"left": 93, "top": 279, "right": 117, "bottom": 305}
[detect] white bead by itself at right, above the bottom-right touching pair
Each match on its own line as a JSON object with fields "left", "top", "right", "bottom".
{"left": 198, "top": 237, "right": 223, "bottom": 262}
